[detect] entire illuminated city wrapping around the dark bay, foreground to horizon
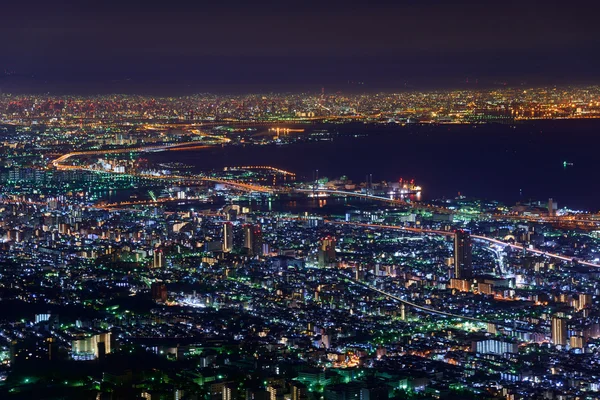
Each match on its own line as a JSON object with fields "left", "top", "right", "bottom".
{"left": 0, "top": 86, "right": 600, "bottom": 400}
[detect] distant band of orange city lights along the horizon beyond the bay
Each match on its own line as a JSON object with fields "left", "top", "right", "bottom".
{"left": 0, "top": 85, "right": 600, "bottom": 126}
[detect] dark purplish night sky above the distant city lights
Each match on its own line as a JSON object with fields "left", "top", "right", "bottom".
{"left": 0, "top": 0, "right": 600, "bottom": 92}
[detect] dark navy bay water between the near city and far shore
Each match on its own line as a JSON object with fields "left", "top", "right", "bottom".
{"left": 147, "top": 119, "right": 600, "bottom": 212}
